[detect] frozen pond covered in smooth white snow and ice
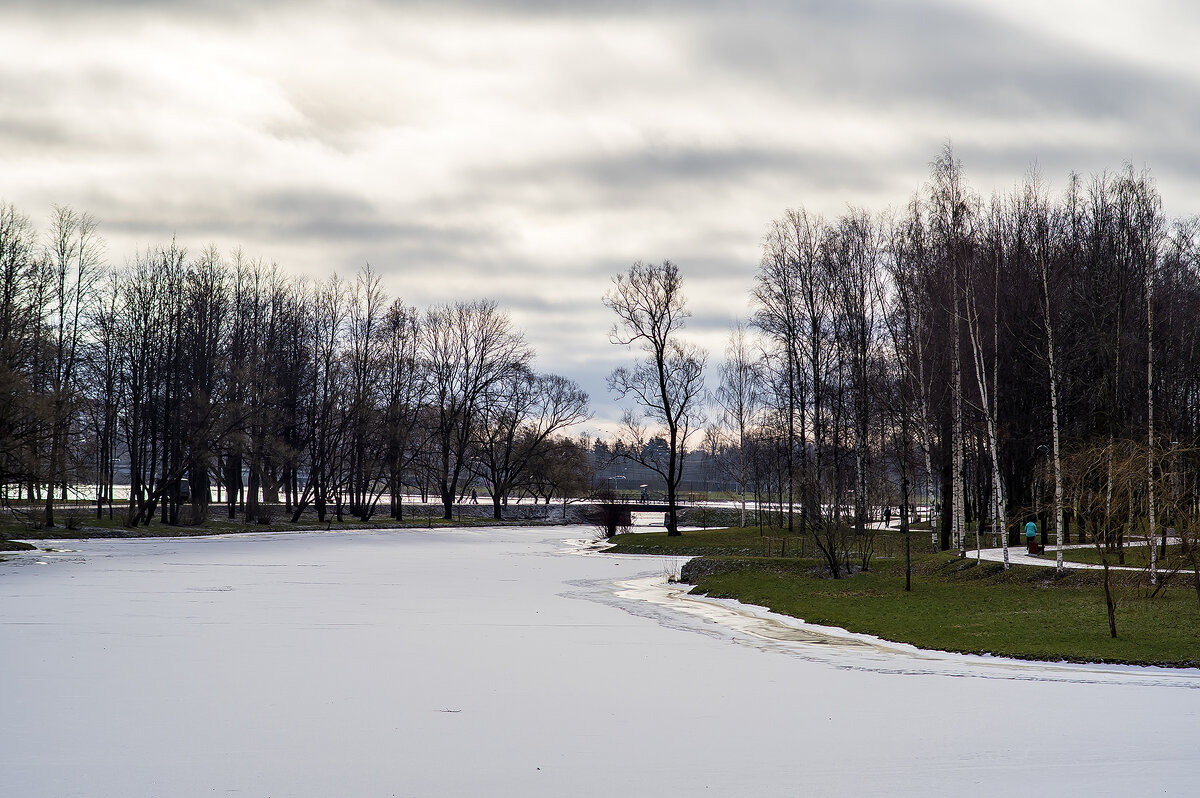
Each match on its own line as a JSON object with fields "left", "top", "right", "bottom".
{"left": 0, "top": 528, "right": 1200, "bottom": 798}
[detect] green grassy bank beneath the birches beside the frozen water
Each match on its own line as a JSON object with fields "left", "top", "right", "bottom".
{"left": 616, "top": 529, "right": 1200, "bottom": 667}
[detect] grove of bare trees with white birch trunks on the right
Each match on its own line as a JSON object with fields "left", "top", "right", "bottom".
{"left": 700, "top": 146, "right": 1200, "bottom": 575}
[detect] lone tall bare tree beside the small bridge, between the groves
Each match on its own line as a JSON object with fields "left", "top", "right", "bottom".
{"left": 604, "top": 260, "right": 707, "bottom": 535}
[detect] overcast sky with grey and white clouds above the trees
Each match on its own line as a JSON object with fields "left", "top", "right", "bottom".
{"left": 0, "top": 0, "right": 1200, "bottom": 428}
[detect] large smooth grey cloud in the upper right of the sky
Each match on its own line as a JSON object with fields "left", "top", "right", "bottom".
{"left": 694, "top": 0, "right": 1200, "bottom": 126}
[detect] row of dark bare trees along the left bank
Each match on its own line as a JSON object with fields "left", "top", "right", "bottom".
{"left": 0, "top": 205, "right": 588, "bottom": 526}
